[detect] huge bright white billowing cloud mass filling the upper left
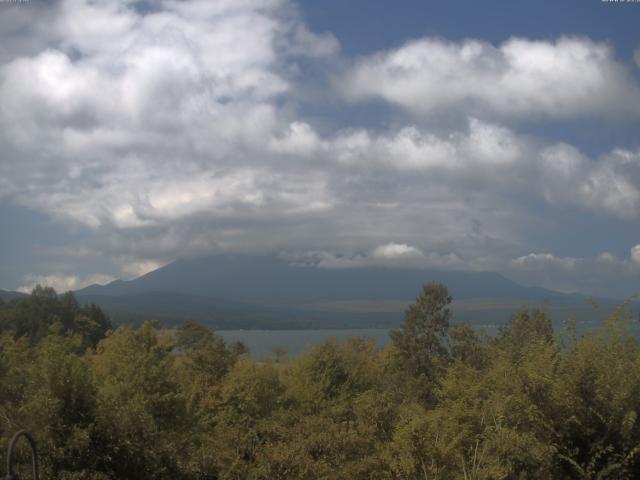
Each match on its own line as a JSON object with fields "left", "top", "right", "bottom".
{"left": 0, "top": 0, "right": 338, "bottom": 232}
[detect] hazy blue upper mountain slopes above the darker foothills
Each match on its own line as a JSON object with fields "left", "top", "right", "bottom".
{"left": 77, "top": 255, "right": 579, "bottom": 305}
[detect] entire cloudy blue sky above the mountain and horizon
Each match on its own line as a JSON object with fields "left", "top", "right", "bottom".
{"left": 0, "top": 0, "right": 640, "bottom": 298}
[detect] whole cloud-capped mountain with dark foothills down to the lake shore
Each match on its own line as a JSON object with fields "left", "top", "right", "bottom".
{"left": 70, "top": 255, "right": 613, "bottom": 329}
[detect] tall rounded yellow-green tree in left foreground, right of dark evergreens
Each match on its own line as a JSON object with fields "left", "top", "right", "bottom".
{"left": 92, "top": 322, "right": 189, "bottom": 479}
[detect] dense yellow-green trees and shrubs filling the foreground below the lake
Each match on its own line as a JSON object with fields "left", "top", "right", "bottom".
{"left": 0, "top": 284, "right": 640, "bottom": 480}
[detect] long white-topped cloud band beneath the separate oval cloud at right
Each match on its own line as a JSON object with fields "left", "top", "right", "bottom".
{"left": 324, "top": 118, "right": 640, "bottom": 221}
